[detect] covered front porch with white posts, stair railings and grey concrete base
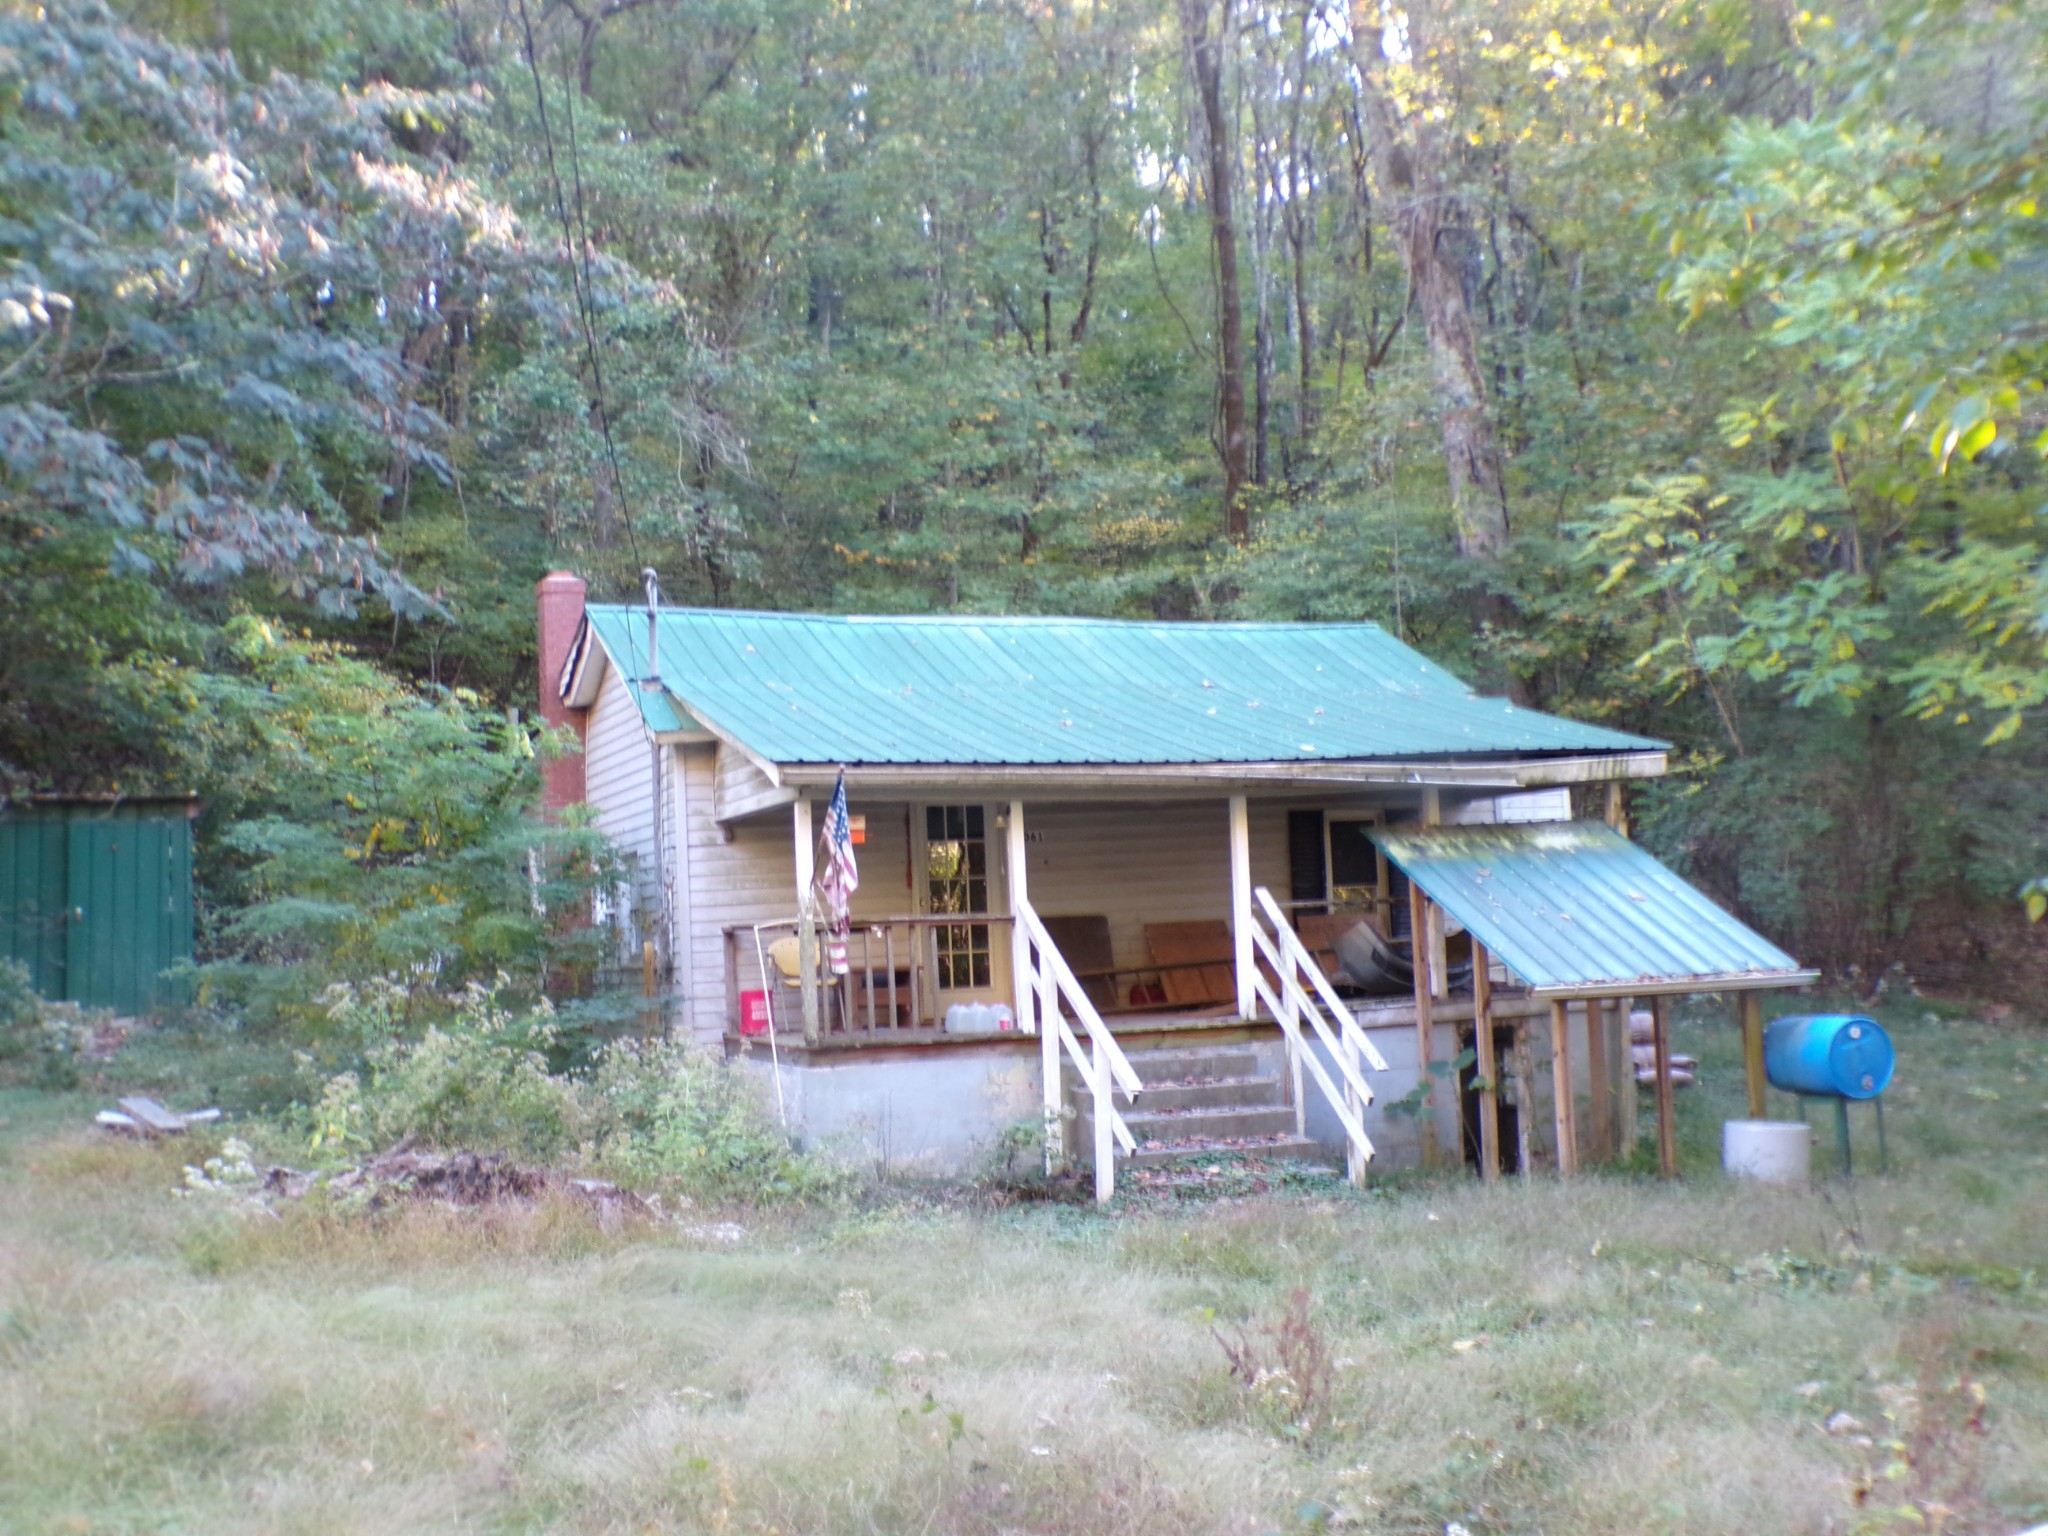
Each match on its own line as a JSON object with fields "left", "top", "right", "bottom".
{"left": 719, "top": 786, "right": 1597, "bottom": 1192}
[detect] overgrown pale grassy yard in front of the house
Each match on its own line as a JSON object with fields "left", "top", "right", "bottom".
{"left": 0, "top": 1006, "right": 2048, "bottom": 1536}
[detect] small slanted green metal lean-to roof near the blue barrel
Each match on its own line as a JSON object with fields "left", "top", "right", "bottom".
{"left": 1372, "top": 821, "right": 1815, "bottom": 997}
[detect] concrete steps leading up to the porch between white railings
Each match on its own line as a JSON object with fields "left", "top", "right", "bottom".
{"left": 1065, "top": 1044, "right": 1327, "bottom": 1167}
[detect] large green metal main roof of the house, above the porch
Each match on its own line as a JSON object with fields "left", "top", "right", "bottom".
{"left": 588, "top": 604, "right": 1665, "bottom": 766}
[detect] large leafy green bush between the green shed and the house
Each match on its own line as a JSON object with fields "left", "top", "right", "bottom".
{"left": 201, "top": 618, "right": 610, "bottom": 1020}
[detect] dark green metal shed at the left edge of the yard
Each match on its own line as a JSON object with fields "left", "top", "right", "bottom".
{"left": 0, "top": 799, "right": 199, "bottom": 1014}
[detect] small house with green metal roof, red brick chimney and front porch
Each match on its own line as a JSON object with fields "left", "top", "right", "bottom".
{"left": 539, "top": 573, "right": 1810, "bottom": 1194}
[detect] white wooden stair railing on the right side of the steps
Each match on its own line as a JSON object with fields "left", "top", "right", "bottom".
{"left": 1251, "top": 885, "right": 1386, "bottom": 1184}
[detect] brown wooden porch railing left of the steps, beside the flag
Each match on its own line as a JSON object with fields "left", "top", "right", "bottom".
{"left": 725, "top": 913, "right": 1022, "bottom": 1040}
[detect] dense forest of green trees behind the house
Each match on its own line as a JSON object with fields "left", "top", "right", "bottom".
{"left": 0, "top": 0, "right": 2048, "bottom": 1011}
